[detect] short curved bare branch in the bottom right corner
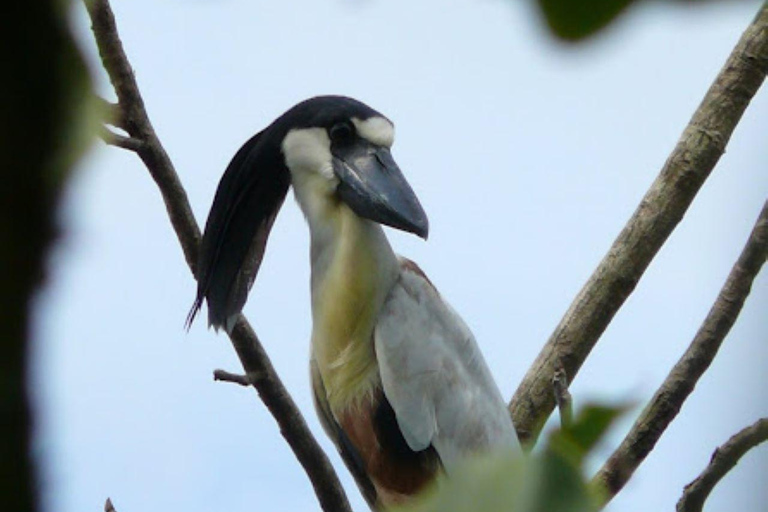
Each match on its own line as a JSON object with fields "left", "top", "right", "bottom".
{"left": 677, "top": 418, "right": 768, "bottom": 512}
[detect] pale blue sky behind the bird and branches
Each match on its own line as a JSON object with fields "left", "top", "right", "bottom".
{"left": 34, "top": 0, "right": 768, "bottom": 512}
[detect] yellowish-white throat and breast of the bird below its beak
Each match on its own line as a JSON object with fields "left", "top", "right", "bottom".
{"left": 310, "top": 203, "right": 398, "bottom": 411}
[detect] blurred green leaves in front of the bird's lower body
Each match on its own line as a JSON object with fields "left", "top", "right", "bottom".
{"left": 391, "top": 405, "right": 627, "bottom": 512}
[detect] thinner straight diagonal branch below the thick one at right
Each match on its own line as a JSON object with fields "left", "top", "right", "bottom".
{"left": 592, "top": 202, "right": 768, "bottom": 502}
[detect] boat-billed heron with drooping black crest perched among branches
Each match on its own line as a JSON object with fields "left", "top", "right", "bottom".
{"left": 187, "top": 96, "right": 520, "bottom": 510}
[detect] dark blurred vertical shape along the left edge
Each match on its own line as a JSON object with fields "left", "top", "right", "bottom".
{"left": 0, "top": 0, "right": 96, "bottom": 512}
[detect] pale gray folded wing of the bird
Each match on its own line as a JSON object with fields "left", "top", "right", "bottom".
{"left": 374, "top": 260, "right": 519, "bottom": 472}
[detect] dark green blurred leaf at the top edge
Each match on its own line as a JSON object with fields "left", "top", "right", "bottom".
{"left": 538, "top": 0, "right": 752, "bottom": 42}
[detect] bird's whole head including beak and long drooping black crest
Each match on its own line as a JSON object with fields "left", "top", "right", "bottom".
{"left": 187, "top": 96, "right": 429, "bottom": 330}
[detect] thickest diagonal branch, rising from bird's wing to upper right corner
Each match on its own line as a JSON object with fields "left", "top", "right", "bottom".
{"left": 509, "top": 4, "right": 768, "bottom": 443}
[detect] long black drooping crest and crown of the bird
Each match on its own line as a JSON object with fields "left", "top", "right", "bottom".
{"left": 186, "top": 96, "right": 381, "bottom": 330}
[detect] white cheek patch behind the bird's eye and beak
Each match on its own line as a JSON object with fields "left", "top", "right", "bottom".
{"left": 281, "top": 128, "right": 335, "bottom": 180}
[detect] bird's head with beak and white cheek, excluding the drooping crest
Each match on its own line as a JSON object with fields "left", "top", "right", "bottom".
{"left": 274, "top": 96, "right": 429, "bottom": 239}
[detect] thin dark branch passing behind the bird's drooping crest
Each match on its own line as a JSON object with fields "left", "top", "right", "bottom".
{"left": 85, "top": 0, "right": 351, "bottom": 512}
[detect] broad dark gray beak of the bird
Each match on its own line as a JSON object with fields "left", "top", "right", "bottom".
{"left": 333, "top": 141, "right": 429, "bottom": 240}
